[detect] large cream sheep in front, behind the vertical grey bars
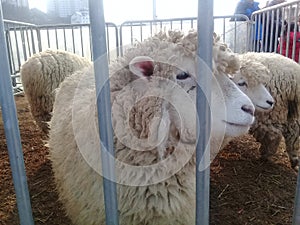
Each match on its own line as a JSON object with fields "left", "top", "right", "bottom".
{"left": 49, "top": 32, "right": 254, "bottom": 225}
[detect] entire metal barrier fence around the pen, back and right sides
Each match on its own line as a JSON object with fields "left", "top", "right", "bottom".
{"left": 4, "top": 0, "right": 300, "bottom": 96}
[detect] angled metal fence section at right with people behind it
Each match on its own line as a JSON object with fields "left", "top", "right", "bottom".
{"left": 249, "top": 0, "right": 300, "bottom": 63}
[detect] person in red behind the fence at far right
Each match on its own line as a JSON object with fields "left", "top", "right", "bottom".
{"left": 277, "top": 22, "right": 300, "bottom": 63}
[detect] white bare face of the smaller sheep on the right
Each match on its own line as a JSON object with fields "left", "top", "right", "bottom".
{"left": 232, "top": 72, "right": 275, "bottom": 111}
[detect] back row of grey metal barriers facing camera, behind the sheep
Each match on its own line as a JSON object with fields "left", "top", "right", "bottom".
{"left": 4, "top": 15, "right": 253, "bottom": 93}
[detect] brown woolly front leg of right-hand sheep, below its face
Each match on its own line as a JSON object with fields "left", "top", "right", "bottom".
{"left": 253, "top": 125, "right": 282, "bottom": 159}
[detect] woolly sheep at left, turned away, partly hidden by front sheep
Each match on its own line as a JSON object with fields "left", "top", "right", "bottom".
{"left": 20, "top": 49, "right": 91, "bottom": 134}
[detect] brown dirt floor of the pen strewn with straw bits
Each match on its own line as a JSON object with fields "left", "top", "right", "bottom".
{"left": 0, "top": 96, "right": 297, "bottom": 225}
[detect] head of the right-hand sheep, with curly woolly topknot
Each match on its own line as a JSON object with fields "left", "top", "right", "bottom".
{"left": 232, "top": 56, "right": 275, "bottom": 111}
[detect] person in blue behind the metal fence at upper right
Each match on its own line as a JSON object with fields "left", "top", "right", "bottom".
{"left": 263, "top": 0, "right": 286, "bottom": 52}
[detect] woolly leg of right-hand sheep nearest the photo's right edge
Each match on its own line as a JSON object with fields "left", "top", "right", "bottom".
{"left": 283, "top": 121, "right": 300, "bottom": 168}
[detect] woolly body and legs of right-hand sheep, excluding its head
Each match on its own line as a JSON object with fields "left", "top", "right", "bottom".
{"left": 234, "top": 52, "right": 300, "bottom": 168}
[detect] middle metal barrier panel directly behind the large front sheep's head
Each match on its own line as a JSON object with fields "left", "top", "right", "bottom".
{"left": 119, "top": 15, "right": 250, "bottom": 55}
